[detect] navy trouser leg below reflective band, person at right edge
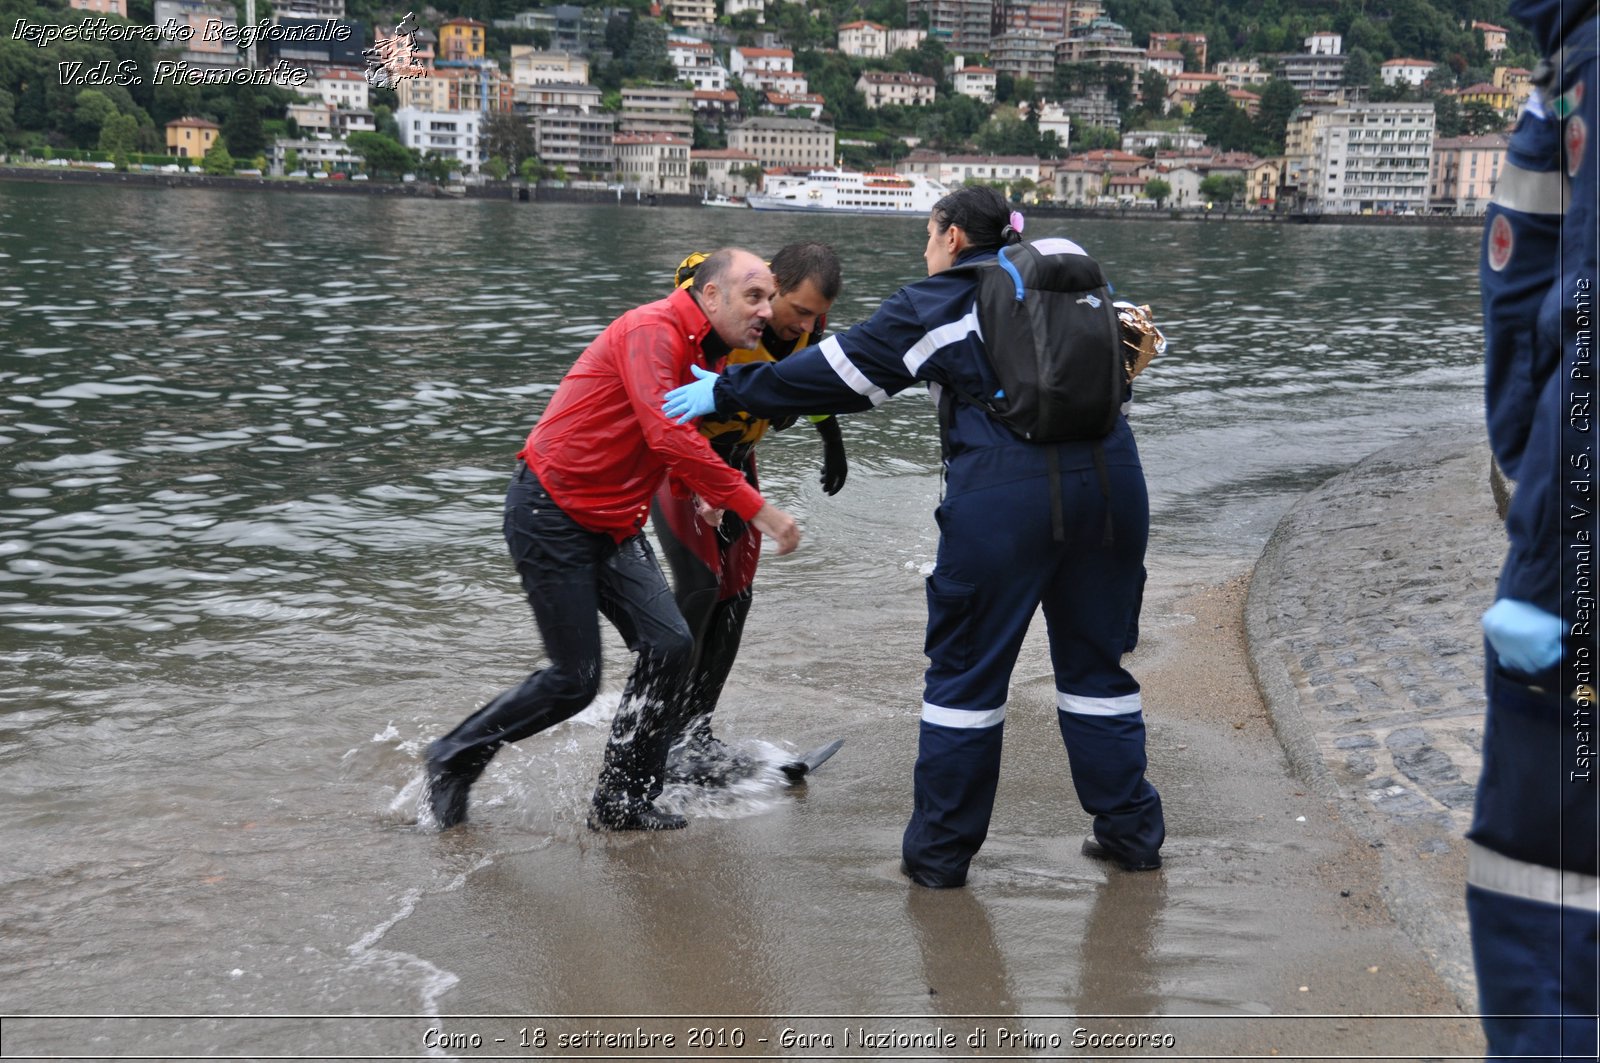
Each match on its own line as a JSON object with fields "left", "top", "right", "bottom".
{"left": 1467, "top": 884, "right": 1600, "bottom": 1060}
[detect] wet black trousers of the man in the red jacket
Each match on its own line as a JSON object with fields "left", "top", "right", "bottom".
{"left": 432, "top": 463, "right": 694, "bottom": 804}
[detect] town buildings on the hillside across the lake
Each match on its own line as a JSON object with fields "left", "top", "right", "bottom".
{"left": 15, "top": 0, "right": 1510, "bottom": 213}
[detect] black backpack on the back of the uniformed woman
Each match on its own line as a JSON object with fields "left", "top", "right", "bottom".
{"left": 944, "top": 239, "right": 1128, "bottom": 443}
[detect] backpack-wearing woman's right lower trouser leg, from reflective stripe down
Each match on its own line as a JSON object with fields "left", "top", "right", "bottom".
{"left": 1056, "top": 692, "right": 1166, "bottom": 856}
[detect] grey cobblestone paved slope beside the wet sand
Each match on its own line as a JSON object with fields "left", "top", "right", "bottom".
{"left": 1245, "top": 427, "right": 1506, "bottom": 1010}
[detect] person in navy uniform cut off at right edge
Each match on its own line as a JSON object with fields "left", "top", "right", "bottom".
{"left": 1467, "top": 0, "right": 1600, "bottom": 1060}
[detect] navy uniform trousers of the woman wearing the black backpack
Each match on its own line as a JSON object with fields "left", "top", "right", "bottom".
{"left": 902, "top": 451, "right": 1166, "bottom": 887}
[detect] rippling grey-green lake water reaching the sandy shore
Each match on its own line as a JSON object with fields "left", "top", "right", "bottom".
{"left": 0, "top": 184, "right": 1493, "bottom": 1057}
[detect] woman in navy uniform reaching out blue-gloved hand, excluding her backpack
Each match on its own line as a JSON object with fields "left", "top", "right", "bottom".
{"left": 666, "top": 187, "right": 1166, "bottom": 889}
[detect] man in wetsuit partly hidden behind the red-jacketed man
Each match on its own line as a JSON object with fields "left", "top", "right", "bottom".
{"left": 651, "top": 243, "right": 846, "bottom": 784}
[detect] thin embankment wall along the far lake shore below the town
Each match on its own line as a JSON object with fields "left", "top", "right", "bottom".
{"left": 0, "top": 165, "right": 1483, "bottom": 229}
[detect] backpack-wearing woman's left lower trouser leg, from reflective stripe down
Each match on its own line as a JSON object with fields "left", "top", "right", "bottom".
{"left": 901, "top": 704, "right": 1005, "bottom": 885}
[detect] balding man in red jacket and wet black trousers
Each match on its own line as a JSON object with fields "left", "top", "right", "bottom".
{"left": 427, "top": 248, "right": 800, "bottom": 831}
